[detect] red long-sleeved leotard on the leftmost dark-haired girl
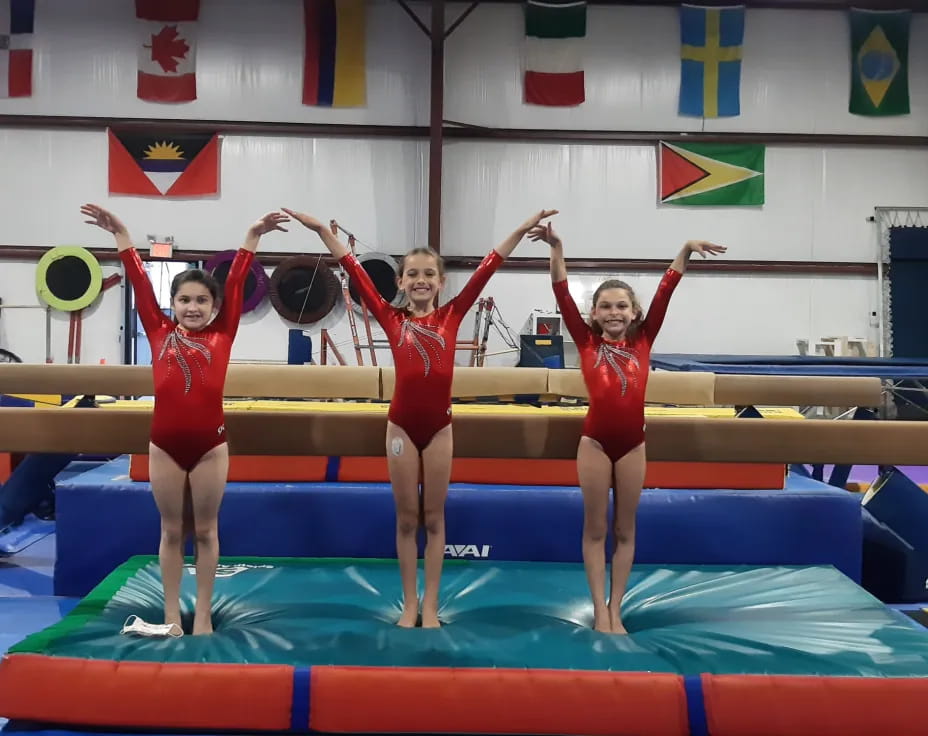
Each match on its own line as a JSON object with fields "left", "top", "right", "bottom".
{"left": 119, "top": 248, "right": 254, "bottom": 472}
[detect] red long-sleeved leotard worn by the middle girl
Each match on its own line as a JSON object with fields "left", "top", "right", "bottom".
{"left": 339, "top": 250, "right": 503, "bottom": 452}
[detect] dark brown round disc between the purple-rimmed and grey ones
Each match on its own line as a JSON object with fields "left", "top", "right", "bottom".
{"left": 269, "top": 256, "right": 341, "bottom": 325}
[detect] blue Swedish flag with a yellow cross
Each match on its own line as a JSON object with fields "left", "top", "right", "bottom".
{"left": 680, "top": 5, "right": 744, "bottom": 118}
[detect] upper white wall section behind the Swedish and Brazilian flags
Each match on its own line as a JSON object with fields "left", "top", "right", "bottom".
{"left": 445, "top": 4, "right": 928, "bottom": 135}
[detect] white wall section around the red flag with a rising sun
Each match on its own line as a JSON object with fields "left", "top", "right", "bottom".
{"left": 0, "top": 129, "right": 427, "bottom": 252}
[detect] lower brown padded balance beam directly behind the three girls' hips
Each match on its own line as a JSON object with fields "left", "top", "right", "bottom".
{"left": 0, "top": 408, "right": 928, "bottom": 465}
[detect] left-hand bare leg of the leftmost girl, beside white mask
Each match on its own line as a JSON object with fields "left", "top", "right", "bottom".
{"left": 148, "top": 444, "right": 187, "bottom": 627}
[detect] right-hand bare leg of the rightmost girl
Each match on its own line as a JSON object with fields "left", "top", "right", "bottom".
{"left": 609, "top": 443, "right": 647, "bottom": 634}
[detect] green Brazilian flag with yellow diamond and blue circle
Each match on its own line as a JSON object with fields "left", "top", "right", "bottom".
{"left": 848, "top": 8, "right": 912, "bottom": 115}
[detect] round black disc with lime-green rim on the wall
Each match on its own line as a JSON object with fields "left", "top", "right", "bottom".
{"left": 35, "top": 245, "right": 103, "bottom": 312}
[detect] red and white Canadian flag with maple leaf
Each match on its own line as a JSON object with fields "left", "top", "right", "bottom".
{"left": 135, "top": 0, "right": 200, "bottom": 102}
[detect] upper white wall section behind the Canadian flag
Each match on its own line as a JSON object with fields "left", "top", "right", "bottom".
{"left": 0, "top": 0, "right": 429, "bottom": 125}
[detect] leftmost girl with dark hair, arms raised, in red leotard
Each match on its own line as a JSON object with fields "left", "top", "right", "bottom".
{"left": 81, "top": 204, "right": 289, "bottom": 634}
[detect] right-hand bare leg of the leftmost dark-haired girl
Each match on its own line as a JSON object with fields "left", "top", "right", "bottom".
{"left": 190, "top": 443, "right": 229, "bottom": 634}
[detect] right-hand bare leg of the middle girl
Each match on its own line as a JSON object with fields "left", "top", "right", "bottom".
{"left": 422, "top": 424, "right": 454, "bottom": 629}
